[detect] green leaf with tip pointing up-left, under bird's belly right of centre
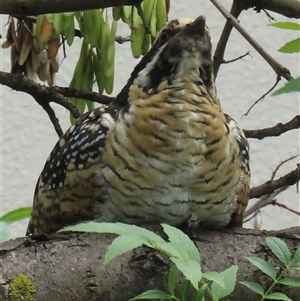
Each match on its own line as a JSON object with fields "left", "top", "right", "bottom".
{"left": 162, "top": 224, "right": 200, "bottom": 263}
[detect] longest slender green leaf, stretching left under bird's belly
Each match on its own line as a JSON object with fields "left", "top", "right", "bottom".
{"left": 59, "top": 222, "right": 165, "bottom": 244}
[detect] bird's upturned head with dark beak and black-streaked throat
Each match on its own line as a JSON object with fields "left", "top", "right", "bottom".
{"left": 134, "top": 16, "right": 214, "bottom": 93}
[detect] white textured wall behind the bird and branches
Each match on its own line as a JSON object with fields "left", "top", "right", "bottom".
{"left": 0, "top": 0, "right": 300, "bottom": 236}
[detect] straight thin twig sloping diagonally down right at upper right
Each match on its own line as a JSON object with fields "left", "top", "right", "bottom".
{"left": 210, "top": 0, "right": 293, "bottom": 80}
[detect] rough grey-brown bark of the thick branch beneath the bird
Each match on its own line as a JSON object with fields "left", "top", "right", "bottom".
{"left": 0, "top": 227, "right": 300, "bottom": 301}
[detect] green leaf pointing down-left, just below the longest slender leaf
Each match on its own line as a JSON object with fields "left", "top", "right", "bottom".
{"left": 102, "top": 235, "right": 146, "bottom": 267}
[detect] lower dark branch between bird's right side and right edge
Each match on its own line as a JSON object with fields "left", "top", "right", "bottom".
{"left": 250, "top": 167, "right": 300, "bottom": 199}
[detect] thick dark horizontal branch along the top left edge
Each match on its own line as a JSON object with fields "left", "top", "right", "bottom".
{"left": 0, "top": 0, "right": 141, "bottom": 16}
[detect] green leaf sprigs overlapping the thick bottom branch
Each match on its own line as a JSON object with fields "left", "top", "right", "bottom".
{"left": 61, "top": 222, "right": 300, "bottom": 301}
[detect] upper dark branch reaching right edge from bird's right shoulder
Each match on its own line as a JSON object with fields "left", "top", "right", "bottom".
{"left": 243, "top": 115, "right": 300, "bottom": 140}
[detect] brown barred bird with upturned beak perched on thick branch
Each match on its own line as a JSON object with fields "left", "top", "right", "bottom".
{"left": 27, "top": 16, "right": 250, "bottom": 235}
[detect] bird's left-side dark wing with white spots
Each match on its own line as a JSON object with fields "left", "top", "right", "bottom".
{"left": 27, "top": 106, "right": 114, "bottom": 235}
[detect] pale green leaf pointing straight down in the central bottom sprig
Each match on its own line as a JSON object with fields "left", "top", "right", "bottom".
{"left": 170, "top": 257, "right": 202, "bottom": 290}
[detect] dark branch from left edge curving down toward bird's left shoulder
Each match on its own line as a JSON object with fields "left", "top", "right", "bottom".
{"left": 0, "top": 71, "right": 81, "bottom": 118}
